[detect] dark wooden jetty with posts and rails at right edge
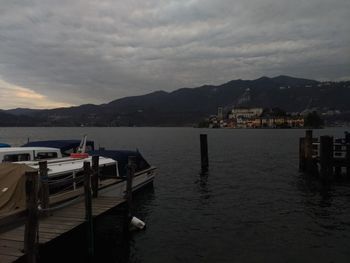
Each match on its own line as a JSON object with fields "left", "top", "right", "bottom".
{"left": 299, "top": 130, "right": 350, "bottom": 180}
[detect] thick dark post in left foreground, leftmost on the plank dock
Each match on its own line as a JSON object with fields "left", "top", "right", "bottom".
{"left": 24, "top": 171, "right": 39, "bottom": 263}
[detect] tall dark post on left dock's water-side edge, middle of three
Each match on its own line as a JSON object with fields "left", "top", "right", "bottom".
{"left": 84, "top": 161, "right": 94, "bottom": 257}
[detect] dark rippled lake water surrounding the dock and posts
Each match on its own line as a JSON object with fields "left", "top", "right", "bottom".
{"left": 0, "top": 128, "right": 350, "bottom": 263}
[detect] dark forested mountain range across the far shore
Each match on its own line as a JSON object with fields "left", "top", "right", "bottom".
{"left": 0, "top": 76, "right": 350, "bottom": 126}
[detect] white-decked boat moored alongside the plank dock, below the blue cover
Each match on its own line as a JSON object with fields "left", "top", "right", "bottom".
{"left": 18, "top": 156, "right": 156, "bottom": 204}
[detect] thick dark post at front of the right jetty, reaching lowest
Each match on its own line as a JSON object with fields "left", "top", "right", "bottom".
{"left": 320, "top": 136, "right": 333, "bottom": 180}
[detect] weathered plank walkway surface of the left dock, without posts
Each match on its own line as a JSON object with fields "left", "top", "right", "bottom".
{"left": 0, "top": 196, "right": 126, "bottom": 263}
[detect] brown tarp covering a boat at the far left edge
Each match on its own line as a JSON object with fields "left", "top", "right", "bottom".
{"left": 0, "top": 163, "right": 36, "bottom": 217}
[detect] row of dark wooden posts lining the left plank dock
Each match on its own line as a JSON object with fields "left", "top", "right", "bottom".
{"left": 18, "top": 156, "right": 135, "bottom": 263}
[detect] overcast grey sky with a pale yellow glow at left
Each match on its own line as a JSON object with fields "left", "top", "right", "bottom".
{"left": 0, "top": 0, "right": 350, "bottom": 109}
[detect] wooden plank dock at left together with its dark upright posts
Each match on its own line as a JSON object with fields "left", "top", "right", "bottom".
{"left": 0, "top": 157, "right": 135, "bottom": 263}
